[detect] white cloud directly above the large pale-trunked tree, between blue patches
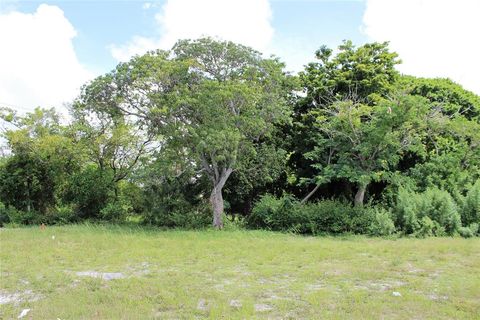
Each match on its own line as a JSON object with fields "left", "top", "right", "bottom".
{"left": 111, "top": 0, "right": 274, "bottom": 61}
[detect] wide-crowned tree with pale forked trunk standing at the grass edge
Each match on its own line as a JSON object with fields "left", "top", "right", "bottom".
{"left": 79, "top": 38, "right": 289, "bottom": 228}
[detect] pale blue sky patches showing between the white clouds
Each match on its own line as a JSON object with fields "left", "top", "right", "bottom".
{"left": 6, "top": 0, "right": 367, "bottom": 72}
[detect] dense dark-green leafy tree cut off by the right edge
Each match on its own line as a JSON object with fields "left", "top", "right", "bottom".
{"left": 397, "top": 76, "right": 480, "bottom": 201}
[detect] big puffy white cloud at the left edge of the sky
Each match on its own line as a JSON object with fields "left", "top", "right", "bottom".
{"left": 0, "top": 4, "right": 92, "bottom": 111}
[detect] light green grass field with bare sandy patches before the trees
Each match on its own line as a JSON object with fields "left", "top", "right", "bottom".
{"left": 0, "top": 226, "right": 480, "bottom": 320}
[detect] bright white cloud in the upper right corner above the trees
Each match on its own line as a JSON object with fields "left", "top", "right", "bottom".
{"left": 363, "top": 0, "right": 480, "bottom": 94}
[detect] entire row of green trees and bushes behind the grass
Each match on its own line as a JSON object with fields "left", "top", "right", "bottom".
{"left": 0, "top": 38, "right": 480, "bottom": 237}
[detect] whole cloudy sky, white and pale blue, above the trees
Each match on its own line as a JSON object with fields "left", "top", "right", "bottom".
{"left": 0, "top": 0, "right": 480, "bottom": 111}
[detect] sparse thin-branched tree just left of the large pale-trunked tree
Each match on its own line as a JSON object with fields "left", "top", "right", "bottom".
{"left": 71, "top": 85, "right": 154, "bottom": 200}
